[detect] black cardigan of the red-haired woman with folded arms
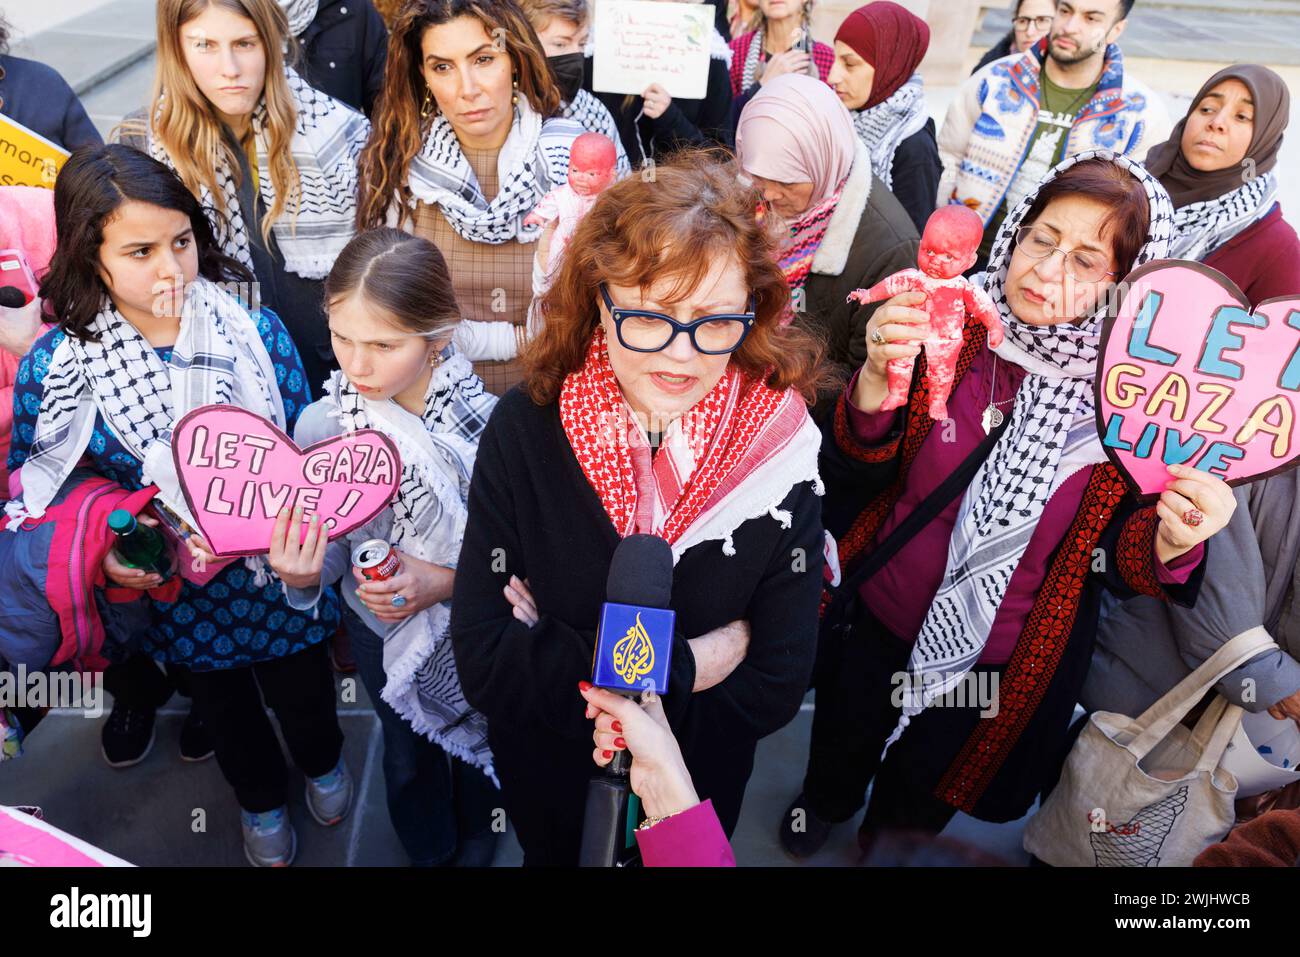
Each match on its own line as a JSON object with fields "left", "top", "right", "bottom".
{"left": 451, "top": 387, "right": 823, "bottom": 865}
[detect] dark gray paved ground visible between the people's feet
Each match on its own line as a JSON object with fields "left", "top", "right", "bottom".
{"left": 0, "top": 683, "right": 1028, "bottom": 866}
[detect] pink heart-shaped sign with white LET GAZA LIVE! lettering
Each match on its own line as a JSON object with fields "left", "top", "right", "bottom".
{"left": 172, "top": 406, "right": 402, "bottom": 558}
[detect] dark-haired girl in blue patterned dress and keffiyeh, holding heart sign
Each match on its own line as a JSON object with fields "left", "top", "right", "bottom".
{"left": 7, "top": 146, "right": 352, "bottom": 865}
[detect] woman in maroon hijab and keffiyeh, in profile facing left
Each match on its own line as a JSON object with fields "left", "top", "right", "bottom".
{"left": 826, "top": 0, "right": 944, "bottom": 233}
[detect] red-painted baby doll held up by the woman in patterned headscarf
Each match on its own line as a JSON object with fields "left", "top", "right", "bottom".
{"left": 849, "top": 205, "right": 1004, "bottom": 420}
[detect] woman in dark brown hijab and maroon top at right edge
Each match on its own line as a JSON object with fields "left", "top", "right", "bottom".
{"left": 1147, "top": 64, "right": 1300, "bottom": 304}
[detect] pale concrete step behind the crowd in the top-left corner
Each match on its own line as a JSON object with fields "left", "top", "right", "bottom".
{"left": 13, "top": 0, "right": 157, "bottom": 95}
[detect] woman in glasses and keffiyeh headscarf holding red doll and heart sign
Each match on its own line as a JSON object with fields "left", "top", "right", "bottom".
{"left": 779, "top": 151, "right": 1234, "bottom": 857}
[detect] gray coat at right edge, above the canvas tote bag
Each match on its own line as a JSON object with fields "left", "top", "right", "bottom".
{"left": 1080, "top": 469, "right": 1300, "bottom": 716}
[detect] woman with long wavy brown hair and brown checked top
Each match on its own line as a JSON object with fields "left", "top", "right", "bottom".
{"left": 358, "top": 0, "right": 584, "bottom": 395}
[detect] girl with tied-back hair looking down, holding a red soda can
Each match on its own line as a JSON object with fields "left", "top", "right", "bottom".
{"left": 270, "top": 229, "right": 498, "bottom": 866}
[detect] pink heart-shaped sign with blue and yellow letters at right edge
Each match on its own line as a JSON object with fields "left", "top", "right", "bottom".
{"left": 1096, "top": 260, "right": 1300, "bottom": 501}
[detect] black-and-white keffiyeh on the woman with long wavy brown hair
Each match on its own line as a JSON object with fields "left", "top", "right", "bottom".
{"left": 407, "top": 96, "right": 584, "bottom": 246}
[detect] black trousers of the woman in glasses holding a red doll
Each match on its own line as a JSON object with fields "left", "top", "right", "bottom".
{"left": 803, "top": 603, "right": 1002, "bottom": 833}
